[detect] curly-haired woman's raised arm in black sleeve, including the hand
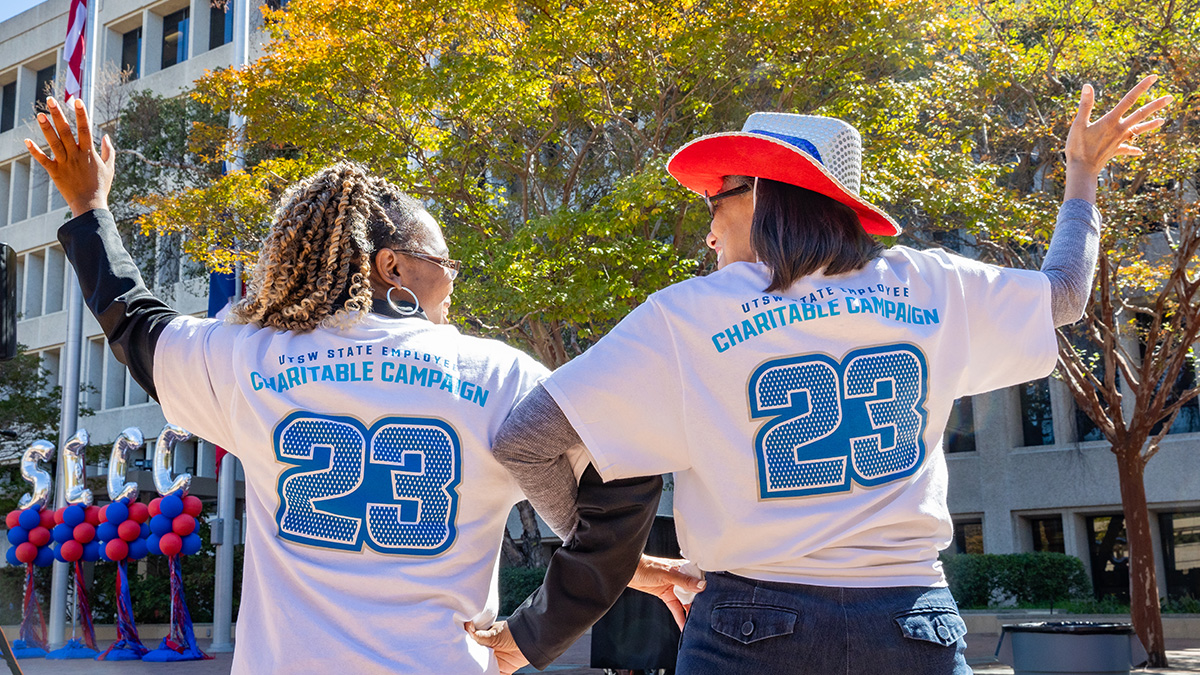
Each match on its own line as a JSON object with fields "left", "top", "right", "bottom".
{"left": 25, "top": 98, "right": 179, "bottom": 400}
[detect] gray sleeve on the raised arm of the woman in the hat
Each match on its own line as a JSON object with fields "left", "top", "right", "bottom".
{"left": 1042, "top": 199, "right": 1100, "bottom": 327}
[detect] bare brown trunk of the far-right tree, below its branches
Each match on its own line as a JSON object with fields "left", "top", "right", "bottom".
{"left": 1115, "top": 448, "right": 1166, "bottom": 668}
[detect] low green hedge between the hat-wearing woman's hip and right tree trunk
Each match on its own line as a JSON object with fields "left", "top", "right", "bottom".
{"left": 941, "top": 552, "right": 1091, "bottom": 608}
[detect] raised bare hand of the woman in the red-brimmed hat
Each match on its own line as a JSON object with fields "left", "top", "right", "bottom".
{"left": 1064, "top": 74, "right": 1175, "bottom": 202}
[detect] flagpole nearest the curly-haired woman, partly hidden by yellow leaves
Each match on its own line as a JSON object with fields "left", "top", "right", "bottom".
{"left": 209, "top": 0, "right": 251, "bottom": 652}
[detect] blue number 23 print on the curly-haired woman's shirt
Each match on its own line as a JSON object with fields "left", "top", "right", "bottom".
{"left": 274, "top": 412, "right": 462, "bottom": 555}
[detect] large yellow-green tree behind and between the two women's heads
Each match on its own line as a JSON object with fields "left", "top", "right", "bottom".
{"left": 129, "top": 0, "right": 932, "bottom": 562}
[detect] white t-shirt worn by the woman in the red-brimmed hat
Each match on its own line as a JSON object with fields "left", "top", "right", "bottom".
{"left": 542, "top": 247, "right": 1056, "bottom": 587}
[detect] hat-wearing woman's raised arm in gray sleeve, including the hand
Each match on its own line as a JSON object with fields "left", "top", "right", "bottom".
{"left": 1042, "top": 76, "right": 1172, "bottom": 325}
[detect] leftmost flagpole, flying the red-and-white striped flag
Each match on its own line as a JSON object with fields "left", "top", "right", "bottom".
{"left": 47, "top": 0, "right": 100, "bottom": 650}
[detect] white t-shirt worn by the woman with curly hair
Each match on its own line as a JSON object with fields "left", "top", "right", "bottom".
{"left": 154, "top": 315, "right": 547, "bottom": 675}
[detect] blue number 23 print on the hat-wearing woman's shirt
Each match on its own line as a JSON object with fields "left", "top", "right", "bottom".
{"left": 749, "top": 345, "right": 926, "bottom": 500}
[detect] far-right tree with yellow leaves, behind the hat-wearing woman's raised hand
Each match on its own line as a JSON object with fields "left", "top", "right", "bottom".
{"left": 902, "top": 0, "right": 1200, "bottom": 667}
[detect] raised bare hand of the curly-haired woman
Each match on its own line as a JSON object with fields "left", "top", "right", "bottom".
{"left": 25, "top": 97, "right": 116, "bottom": 216}
